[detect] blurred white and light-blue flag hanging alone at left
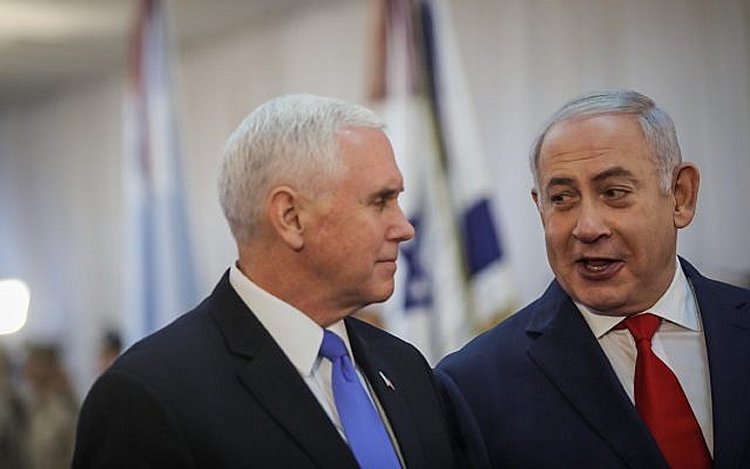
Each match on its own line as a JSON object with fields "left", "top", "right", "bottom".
{"left": 123, "top": 0, "right": 197, "bottom": 343}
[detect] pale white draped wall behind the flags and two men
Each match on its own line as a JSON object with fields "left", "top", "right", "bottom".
{"left": 0, "top": 0, "right": 750, "bottom": 392}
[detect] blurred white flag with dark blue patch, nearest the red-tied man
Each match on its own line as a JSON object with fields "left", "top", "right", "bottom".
{"left": 423, "top": 0, "right": 516, "bottom": 332}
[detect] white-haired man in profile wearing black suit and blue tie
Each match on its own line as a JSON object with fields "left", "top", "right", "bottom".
{"left": 73, "top": 95, "right": 454, "bottom": 469}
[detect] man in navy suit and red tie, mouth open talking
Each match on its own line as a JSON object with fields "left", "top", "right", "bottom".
{"left": 437, "top": 90, "right": 750, "bottom": 469}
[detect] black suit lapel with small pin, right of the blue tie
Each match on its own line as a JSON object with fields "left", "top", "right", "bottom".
{"left": 345, "top": 318, "right": 426, "bottom": 468}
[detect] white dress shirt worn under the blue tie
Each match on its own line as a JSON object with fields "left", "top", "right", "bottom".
{"left": 229, "top": 265, "right": 403, "bottom": 460}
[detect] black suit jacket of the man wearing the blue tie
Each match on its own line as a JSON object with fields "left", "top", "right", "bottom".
{"left": 73, "top": 274, "right": 454, "bottom": 468}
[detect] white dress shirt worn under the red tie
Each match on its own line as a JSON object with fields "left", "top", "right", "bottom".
{"left": 576, "top": 261, "right": 714, "bottom": 455}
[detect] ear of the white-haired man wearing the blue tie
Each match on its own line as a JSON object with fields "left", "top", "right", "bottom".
{"left": 267, "top": 186, "right": 304, "bottom": 251}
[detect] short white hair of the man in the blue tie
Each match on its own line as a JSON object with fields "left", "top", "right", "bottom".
{"left": 218, "top": 94, "right": 384, "bottom": 242}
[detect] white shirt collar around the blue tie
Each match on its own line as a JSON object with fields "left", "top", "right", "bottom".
{"left": 229, "top": 265, "right": 351, "bottom": 376}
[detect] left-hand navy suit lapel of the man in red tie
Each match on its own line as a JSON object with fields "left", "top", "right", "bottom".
{"left": 527, "top": 282, "right": 665, "bottom": 467}
